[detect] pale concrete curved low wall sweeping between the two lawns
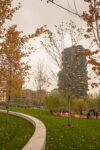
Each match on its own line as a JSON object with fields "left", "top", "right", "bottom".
{"left": 0, "top": 110, "right": 46, "bottom": 150}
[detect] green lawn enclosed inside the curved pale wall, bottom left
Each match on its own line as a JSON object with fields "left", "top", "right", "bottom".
{"left": 0, "top": 113, "right": 35, "bottom": 150}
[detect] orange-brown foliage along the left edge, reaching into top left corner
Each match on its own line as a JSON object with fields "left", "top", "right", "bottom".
{"left": 0, "top": 0, "right": 20, "bottom": 89}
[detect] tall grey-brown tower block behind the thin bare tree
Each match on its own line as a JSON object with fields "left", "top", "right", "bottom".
{"left": 58, "top": 45, "right": 88, "bottom": 97}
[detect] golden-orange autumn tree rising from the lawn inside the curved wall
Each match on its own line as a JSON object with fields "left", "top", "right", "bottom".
{"left": 0, "top": 25, "right": 29, "bottom": 122}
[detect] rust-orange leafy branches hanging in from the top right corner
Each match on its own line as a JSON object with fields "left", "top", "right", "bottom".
{"left": 41, "top": 0, "right": 100, "bottom": 87}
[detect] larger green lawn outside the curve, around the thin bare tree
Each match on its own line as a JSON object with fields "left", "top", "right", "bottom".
{"left": 0, "top": 108, "right": 100, "bottom": 150}
